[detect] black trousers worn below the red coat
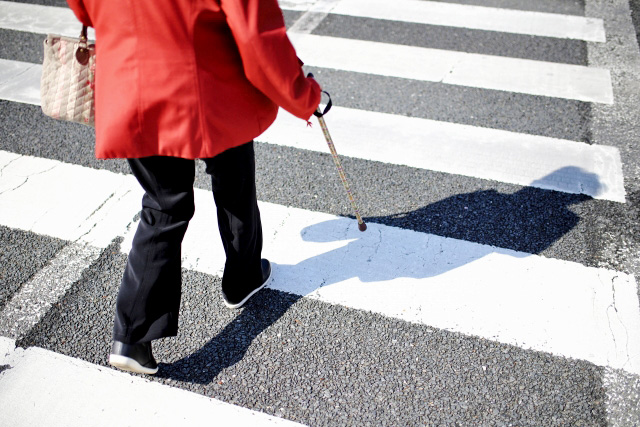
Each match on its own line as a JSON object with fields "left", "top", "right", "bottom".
{"left": 113, "top": 142, "right": 262, "bottom": 344}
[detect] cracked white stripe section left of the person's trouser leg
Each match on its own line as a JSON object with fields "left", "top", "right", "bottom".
{"left": 0, "top": 151, "right": 142, "bottom": 248}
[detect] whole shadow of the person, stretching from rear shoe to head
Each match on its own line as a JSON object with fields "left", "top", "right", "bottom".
{"left": 158, "top": 168, "right": 597, "bottom": 384}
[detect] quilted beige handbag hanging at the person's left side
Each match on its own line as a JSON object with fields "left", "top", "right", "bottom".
{"left": 40, "top": 26, "right": 96, "bottom": 126}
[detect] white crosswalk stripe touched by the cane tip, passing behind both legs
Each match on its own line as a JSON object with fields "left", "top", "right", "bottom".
{"left": 0, "top": 152, "right": 640, "bottom": 374}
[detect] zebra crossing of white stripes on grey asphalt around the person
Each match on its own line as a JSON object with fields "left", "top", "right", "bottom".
{"left": 0, "top": 0, "right": 640, "bottom": 425}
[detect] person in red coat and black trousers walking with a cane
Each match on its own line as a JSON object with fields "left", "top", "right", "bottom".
{"left": 67, "top": 0, "right": 321, "bottom": 374}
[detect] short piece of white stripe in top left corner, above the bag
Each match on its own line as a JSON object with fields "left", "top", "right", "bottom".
{"left": 0, "top": 1, "right": 95, "bottom": 40}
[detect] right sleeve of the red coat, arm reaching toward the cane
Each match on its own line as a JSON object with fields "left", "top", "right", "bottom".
{"left": 220, "top": 0, "right": 321, "bottom": 120}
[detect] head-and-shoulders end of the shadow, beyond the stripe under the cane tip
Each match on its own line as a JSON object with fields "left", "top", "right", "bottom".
{"left": 368, "top": 166, "right": 603, "bottom": 254}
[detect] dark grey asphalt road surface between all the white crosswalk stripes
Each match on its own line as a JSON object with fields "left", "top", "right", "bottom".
{"left": 0, "top": 0, "right": 640, "bottom": 426}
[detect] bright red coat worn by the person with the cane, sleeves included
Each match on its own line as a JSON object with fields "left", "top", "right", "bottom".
{"left": 67, "top": 0, "right": 320, "bottom": 159}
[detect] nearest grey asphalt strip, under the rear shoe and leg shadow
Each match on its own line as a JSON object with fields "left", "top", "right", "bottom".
{"left": 17, "top": 241, "right": 606, "bottom": 426}
